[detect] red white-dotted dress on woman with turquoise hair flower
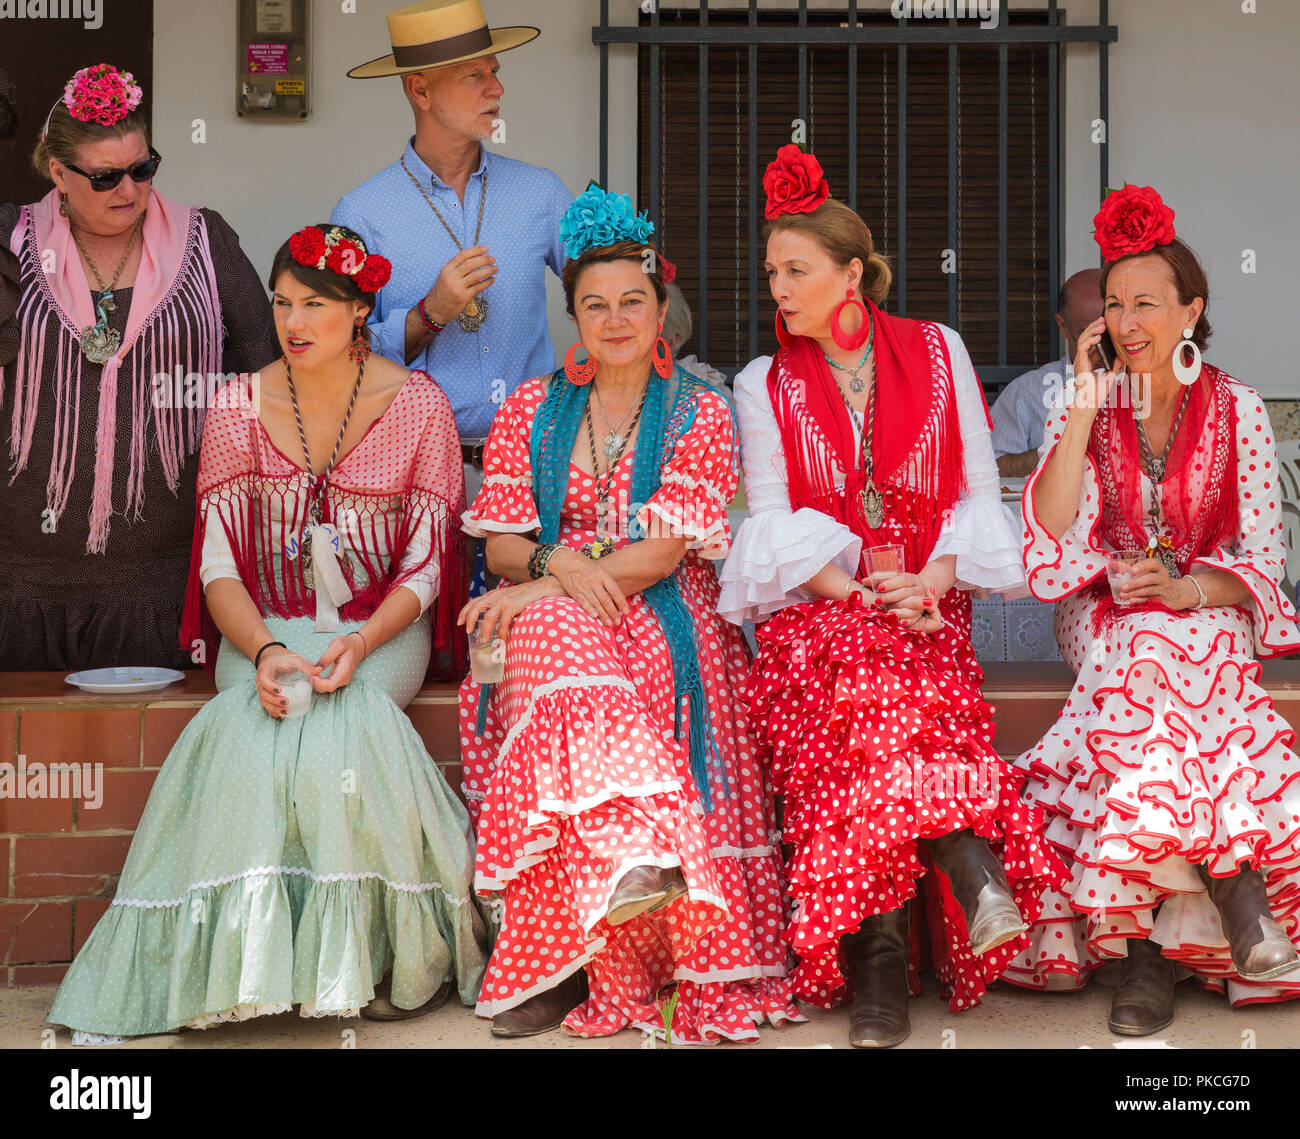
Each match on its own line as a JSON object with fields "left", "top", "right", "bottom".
{"left": 460, "top": 380, "right": 802, "bottom": 1043}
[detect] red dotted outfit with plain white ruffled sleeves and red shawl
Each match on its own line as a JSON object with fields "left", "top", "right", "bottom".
{"left": 722, "top": 309, "right": 1065, "bottom": 1010}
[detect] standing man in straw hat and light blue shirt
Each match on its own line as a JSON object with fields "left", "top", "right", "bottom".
{"left": 330, "top": 5, "right": 573, "bottom": 455}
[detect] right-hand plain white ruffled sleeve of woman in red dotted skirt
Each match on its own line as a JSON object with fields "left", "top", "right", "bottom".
{"left": 930, "top": 325, "right": 1030, "bottom": 597}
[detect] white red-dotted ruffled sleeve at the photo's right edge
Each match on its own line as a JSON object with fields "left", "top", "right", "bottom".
{"left": 1191, "top": 382, "right": 1300, "bottom": 657}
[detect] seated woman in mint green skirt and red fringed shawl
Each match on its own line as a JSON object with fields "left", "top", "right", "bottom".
{"left": 49, "top": 226, "right": 488, "bottom": 1043}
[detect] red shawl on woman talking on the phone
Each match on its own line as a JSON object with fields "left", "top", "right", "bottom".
{"left": 1088, "top": 364, "right": 1238, "bottom": 633}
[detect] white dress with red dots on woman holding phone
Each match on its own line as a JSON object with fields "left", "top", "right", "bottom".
{"left": 1006, "top": 377, "right": 1300, "bottom": 1005}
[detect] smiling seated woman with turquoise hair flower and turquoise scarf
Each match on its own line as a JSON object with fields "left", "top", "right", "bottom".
{"left": 460, "top": 189, "right": 802, "bottom": 1044}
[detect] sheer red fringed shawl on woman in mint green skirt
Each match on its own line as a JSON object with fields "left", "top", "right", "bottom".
{"left": 181, "top": 372, "right": 468, "bottom": 679}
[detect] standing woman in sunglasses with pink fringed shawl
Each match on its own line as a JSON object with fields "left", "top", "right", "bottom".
{"left": 0, "top": 64, "right": 278, "bottom": 670}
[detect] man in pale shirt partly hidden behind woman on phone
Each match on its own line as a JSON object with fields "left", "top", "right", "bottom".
{"left": 991, "top": 269, "right": 1101, "bottom": 478}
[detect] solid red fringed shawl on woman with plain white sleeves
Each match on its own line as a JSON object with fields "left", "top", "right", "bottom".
{"left": 767, "top": 302, "right": 966, "bottom": 587}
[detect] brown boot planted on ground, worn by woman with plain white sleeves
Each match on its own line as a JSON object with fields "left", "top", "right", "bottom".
{"left": 844, "top": 905, "right": 911, "bottom": 1048}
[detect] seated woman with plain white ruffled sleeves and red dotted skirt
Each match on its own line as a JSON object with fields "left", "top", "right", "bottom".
{"left": 722, "top": 147, "right": 1065, "bottom": 1048}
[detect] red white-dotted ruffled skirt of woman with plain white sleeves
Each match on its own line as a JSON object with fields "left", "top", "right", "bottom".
{"left": 749, "top": 596, "right": 1065, "bottom": 1010}
